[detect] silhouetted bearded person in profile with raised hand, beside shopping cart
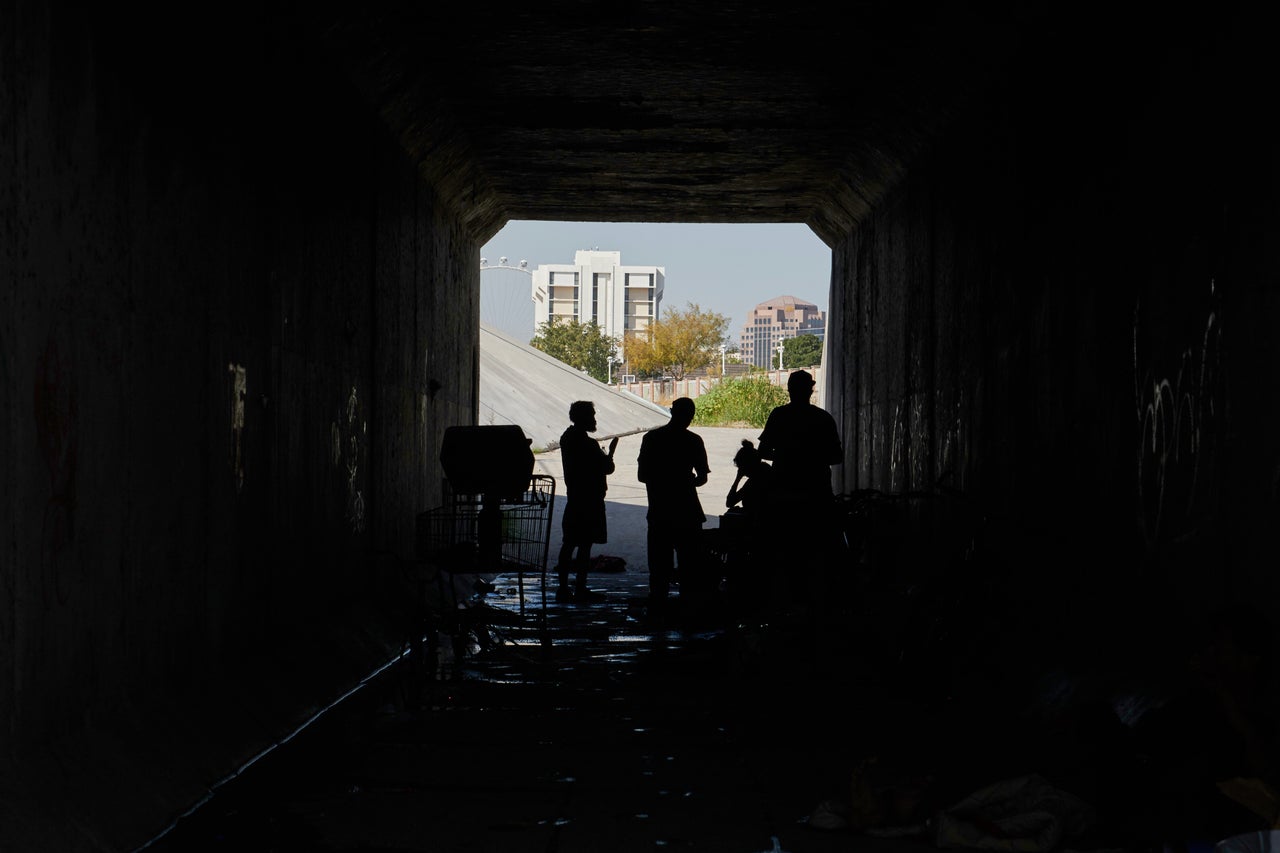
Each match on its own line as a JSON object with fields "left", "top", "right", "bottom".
{"left": 556, "top": 400, "right": 618, "bottom": 601}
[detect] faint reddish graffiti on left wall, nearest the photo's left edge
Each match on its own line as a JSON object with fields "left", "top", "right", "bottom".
{"left": 32, "top": 332, "right": 78, "bottom": 608}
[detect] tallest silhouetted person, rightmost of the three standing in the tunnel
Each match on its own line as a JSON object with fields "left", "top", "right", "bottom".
{"left": 760, "top": 370, "right": 845, "bottom": 606}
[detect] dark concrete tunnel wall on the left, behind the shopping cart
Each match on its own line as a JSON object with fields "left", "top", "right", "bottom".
{"left": 0, "top": 4, "right": 479, "bottom": 850}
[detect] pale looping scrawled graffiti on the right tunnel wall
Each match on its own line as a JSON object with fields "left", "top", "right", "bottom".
{"left": 1133, "top": 280, "right": 1225, "bottom": 552}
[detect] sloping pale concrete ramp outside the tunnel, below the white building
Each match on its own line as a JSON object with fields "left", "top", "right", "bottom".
{"left": 479, "top": 323, "right": 671, "bottom": 451}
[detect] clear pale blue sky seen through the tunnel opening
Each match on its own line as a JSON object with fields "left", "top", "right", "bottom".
{"left": 480, "top": 220, "right": 831, "bottom": 343}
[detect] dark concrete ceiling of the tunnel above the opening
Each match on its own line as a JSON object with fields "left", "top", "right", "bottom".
{"left": 307, "top": 0, "right": 1039, "bottom": 245}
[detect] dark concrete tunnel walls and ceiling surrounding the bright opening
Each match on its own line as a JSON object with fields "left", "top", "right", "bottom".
{"left": 0, "top": 0, "right": 1280, "bottom": 852}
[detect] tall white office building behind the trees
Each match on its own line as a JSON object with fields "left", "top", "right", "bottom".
{"left": 532, "top": 248, "right": 666, "bottom": 338}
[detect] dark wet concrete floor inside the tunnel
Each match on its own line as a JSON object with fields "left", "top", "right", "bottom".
{"left": 140, "top": 558, "right": 967, "bottom": 853}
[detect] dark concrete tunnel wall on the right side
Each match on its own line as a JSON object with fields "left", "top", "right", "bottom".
{"left": 828, "top": 9, "right": 1280, "bottom": 671}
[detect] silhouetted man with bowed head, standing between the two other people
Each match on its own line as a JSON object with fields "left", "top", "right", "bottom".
{"left": 636, "top": 397, "right": 712, "bottom": 619}
